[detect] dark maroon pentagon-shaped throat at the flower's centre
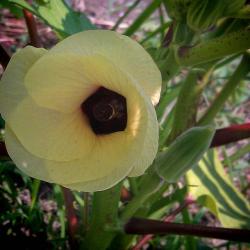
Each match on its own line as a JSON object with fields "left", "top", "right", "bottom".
{"left": 81, "top": 87, "right": 127, "bottom": 135}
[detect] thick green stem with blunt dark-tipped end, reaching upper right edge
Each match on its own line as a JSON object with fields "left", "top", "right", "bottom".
{"left": 175, "top": 28, "right": 250, "bottom": 66}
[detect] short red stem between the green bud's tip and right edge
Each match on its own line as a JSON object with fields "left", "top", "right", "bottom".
{"left": 210, "top": 123, "right": 250, "bottom": 147}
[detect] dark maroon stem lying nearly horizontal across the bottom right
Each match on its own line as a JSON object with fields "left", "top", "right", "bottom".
{"left": 124, "top": 218, "right": 250, "bottom": 242}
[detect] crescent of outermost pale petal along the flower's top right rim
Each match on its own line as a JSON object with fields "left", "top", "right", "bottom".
{"left": 50, "top": 30, "right": 162, "bottom": 105}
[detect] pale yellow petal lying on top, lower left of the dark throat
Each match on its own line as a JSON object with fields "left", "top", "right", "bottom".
{"left": 6, "top": 96, "right": 95, "bottom": 161}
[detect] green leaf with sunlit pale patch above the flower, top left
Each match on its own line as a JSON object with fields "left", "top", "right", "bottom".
{"left": 10, "top": 0, "right": 96, "bottom": 37}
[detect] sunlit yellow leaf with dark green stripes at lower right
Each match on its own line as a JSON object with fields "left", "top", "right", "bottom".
{"left": 187, "top": 150, "right": 250, "bottom": 228}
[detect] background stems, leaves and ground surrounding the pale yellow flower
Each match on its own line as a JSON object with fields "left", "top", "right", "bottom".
{"left": 0, "top": 0, "right": 250, "bottom": 250}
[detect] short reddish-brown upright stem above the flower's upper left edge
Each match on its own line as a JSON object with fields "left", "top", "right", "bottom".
{"left": 23, "top": 10, "right": 42, "bottom": 48}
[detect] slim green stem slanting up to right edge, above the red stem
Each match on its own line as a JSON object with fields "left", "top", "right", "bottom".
{"left": 198, "top": 54, "right": 250, "bottom": 126}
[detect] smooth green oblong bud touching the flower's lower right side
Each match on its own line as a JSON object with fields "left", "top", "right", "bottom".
{"left": 156, "top": 126, "right": 214, "bottom": 183}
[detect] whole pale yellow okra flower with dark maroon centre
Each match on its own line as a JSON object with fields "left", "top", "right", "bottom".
{"left": 0, "top": 30, "right": 161, "bottom": 191}
